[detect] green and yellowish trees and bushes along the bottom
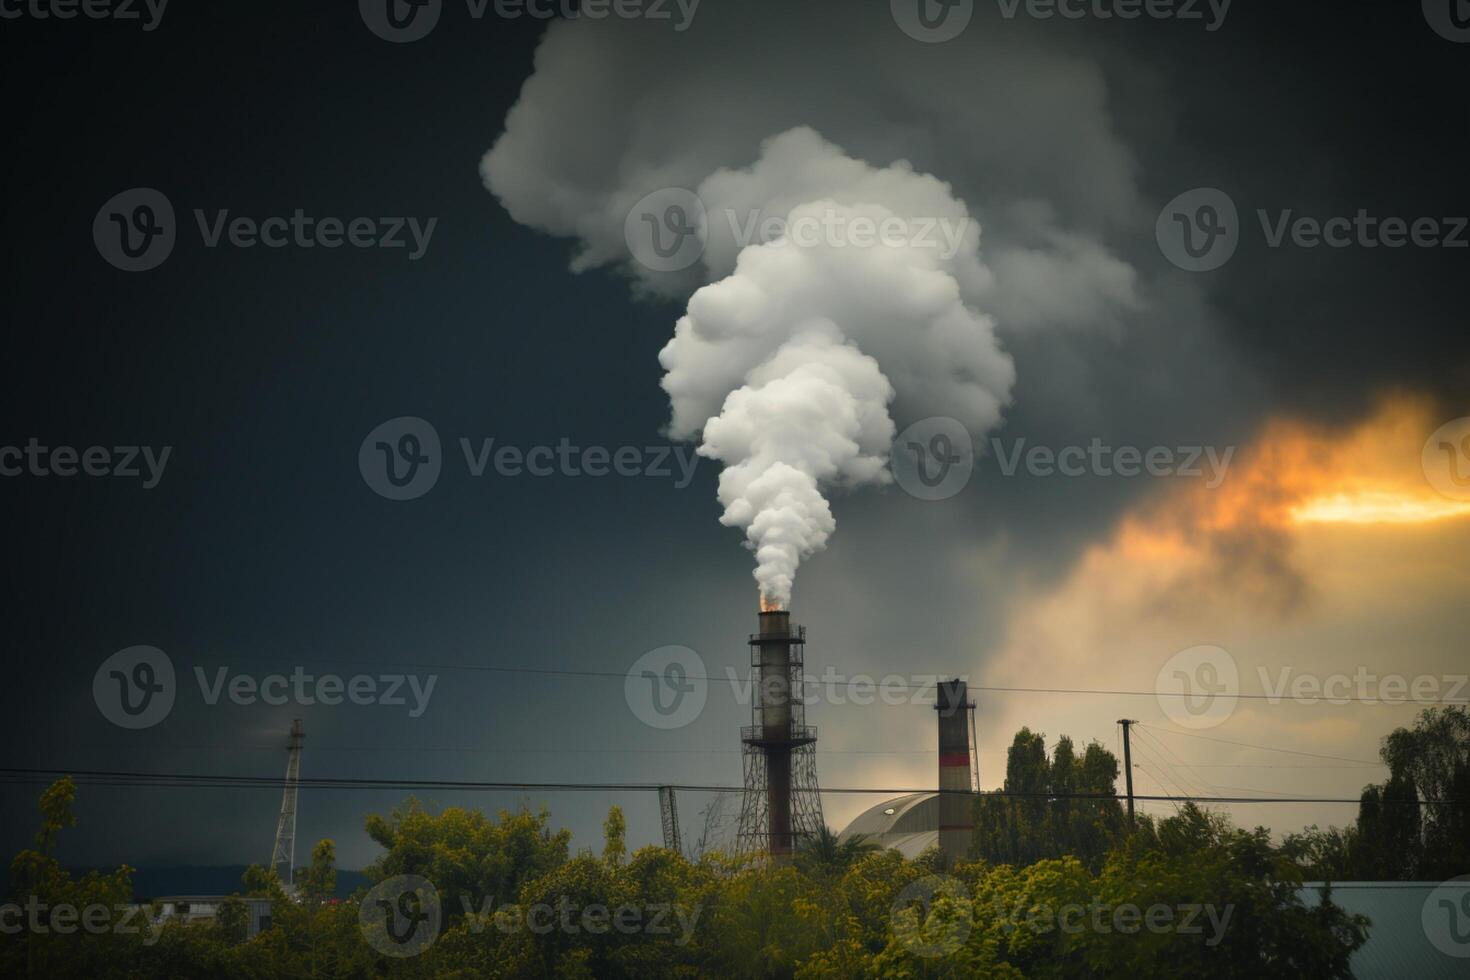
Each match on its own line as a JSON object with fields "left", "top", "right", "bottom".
{"left": 0, "top": 710, "right": 1470, "bottom": 979}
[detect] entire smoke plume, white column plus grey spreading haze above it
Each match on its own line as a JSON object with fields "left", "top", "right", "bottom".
{"left": 482, "top": 13, "right": 1139, "bottom": 605}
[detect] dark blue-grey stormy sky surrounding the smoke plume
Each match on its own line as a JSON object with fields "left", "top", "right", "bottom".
{"left": 0, "top": 0, "right": 1470, "bottom": 867}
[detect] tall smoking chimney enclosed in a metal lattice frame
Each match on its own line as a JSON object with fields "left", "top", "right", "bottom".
{"left": 736, "top": 610, "right": 823, "bottom": 858}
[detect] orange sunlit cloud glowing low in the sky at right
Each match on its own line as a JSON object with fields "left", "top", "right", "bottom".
{"left": 980, "top": 395, "right": 1470, "bottom": 829}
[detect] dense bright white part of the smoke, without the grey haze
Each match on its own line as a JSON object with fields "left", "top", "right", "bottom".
{"left": 660, "top": 129, "right": 1014, "bottom": 605}
